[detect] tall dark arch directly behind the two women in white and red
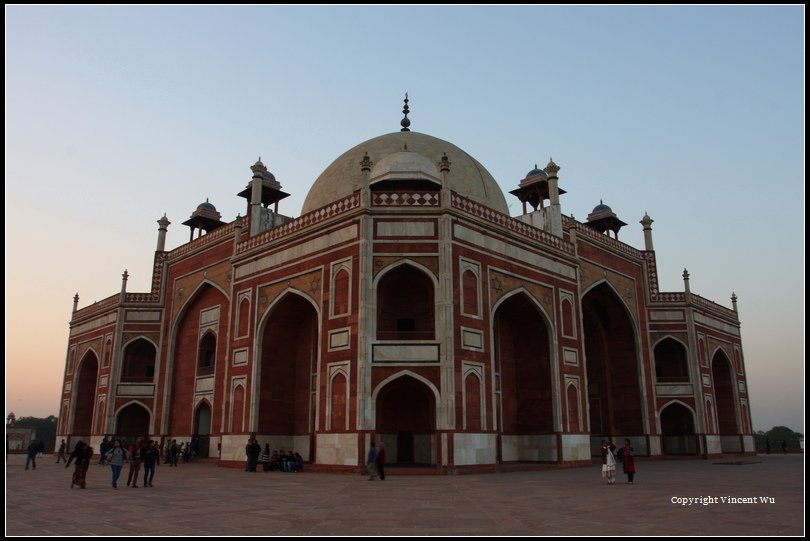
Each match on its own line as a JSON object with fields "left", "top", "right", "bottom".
{"left": 582, "top": 282, "right": 644, "bottom": 454}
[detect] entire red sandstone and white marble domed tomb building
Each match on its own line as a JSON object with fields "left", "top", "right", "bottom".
{"left": 57, "top": 132, "right": 754, "bottom": 471}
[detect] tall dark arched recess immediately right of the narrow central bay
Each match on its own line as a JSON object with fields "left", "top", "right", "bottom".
{"left": 493, "top": 293, "right": 557, "bottom": 462}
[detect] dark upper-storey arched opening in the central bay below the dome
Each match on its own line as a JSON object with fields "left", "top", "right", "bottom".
{"left": 375, "top": 261, "right": 436, "bottom": 340}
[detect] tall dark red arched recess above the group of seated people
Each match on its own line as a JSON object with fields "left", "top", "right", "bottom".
{"left": 258, "top": 293, "right": 318, "bottom": 461}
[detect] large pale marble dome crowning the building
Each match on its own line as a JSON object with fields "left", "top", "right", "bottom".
{"left": 301, "top": 131, "right": 509, "bottom": 214}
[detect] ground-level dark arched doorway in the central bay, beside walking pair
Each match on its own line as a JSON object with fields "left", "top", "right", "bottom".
{"left": 377, "top": 375, "right": 436, "bottom": 466}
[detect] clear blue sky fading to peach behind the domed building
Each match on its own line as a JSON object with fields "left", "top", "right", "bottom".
{"left": 5, "top": 6, "right": 805, "bottom": 432}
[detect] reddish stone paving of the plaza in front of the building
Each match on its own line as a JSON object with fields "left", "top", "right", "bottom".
{"left": 6, "top": 455, "right": 804, "bottom": 536}
